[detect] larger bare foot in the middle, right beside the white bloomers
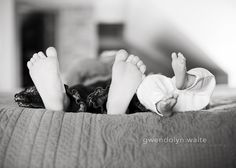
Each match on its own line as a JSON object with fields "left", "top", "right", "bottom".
{"left": 107, "top": 50, "right": 146, "bottom": 114}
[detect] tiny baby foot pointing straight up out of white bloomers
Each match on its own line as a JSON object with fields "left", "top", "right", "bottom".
{"left": 171, "top": 53, "right": 187, "bottom": 89}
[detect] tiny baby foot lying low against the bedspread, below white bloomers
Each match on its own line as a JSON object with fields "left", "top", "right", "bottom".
{"left": 156, "top": 94, "right": 178, "bottom": 117}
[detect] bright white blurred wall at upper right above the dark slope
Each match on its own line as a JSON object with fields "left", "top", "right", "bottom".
{"left": 126, "top": 0, "right": 236, "bottom": 87}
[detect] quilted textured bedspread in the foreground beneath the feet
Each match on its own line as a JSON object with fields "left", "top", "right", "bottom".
{"left": 0, "top": 92, "right": 236, "bottom": 168}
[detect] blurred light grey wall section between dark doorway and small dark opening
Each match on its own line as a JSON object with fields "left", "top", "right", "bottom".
{"left": 55, "top": 5, "right": 97, "bottom": 72}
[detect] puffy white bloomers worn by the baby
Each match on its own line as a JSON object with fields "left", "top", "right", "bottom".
{"left": 137, "top": 68, "right": 216, "bottom": 116}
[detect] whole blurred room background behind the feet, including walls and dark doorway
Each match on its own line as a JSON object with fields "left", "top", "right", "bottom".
{"left": 0, "top": 0, "right": 236, "bottom": 92}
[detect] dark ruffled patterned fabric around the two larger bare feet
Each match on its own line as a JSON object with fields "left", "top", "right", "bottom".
{"left": 15, "top": 80, "right": 147, "bottom": 114}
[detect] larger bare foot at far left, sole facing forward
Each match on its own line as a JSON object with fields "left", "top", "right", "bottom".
{"left": 27, "top": 47, "right": 68, "bottom": 110}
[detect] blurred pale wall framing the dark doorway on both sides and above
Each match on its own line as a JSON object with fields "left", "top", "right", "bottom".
{"left": 0, "top": 0, "right": 97, "bottom": 92}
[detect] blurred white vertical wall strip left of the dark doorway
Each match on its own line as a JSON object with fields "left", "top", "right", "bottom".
{"left": 0, "top": 0, "right": 20, "bottom": 92}
